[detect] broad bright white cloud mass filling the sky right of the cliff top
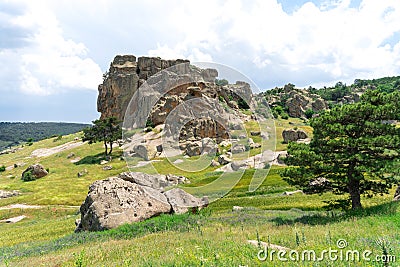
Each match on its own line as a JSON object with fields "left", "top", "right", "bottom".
{"left": 145, "top": 0, "right": 400, "bottom": 86}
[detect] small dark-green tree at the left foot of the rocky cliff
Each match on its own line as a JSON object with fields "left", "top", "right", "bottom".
{"left": 82, "top": 117, "right": 122, "bottom": 156}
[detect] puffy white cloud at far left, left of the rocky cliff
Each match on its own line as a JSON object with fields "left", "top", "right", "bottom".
{"left": 0, "top": 1, "right": 102, "bottom": 95}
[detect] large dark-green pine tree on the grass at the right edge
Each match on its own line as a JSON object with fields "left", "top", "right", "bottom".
{"left": 282, "top": 91, "right": 400, "bottom": 209}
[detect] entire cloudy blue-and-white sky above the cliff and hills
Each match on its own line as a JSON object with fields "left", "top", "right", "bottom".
{"left": 0, "top": 0, "right": 400, "bottom": 122}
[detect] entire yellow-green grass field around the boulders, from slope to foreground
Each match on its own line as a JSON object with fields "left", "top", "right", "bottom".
{"left": 0, "top": 129, "right": 400, "bottom": 266}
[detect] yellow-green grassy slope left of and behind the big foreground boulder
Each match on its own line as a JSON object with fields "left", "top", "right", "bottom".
{"left": 0, "top": 135, "right": 127, "bottom": 206}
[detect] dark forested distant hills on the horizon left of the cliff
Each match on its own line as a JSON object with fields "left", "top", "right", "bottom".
{"left": 0, "top": 122, "right": 89, "bottom": 151}
